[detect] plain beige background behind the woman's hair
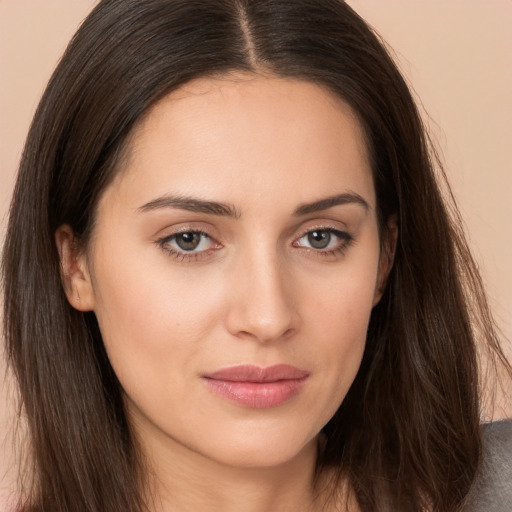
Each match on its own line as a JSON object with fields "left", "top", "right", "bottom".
{"left": 0, "top": 0, "right": 512, "bottom": 504}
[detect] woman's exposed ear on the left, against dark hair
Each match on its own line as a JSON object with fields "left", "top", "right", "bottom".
{"left": 55, "top": 224, "right": 94, "bottom": 311}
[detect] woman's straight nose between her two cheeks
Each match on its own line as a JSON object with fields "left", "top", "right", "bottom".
{"left": 226, "top": 249, "right": 300, "bottom": 342}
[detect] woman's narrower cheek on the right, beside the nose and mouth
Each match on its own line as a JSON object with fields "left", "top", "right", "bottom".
{"left": 294, "top": 251, "right": 378, "bottom": 418}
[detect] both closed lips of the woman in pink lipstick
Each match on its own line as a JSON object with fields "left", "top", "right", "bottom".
{"left": 203, "top": 364, "right": 309, "bottom": 409}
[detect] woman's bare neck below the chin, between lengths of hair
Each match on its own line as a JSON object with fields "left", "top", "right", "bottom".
{"left": 143, "top": 432, "right": 328, "bottom": 512}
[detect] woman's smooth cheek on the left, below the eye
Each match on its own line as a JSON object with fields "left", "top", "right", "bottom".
{"left": 88, "top": 242, "right": 224, "bottom": 385}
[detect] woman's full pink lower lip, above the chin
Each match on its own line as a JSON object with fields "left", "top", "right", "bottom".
{"left": 204, "top": 377, "right": 307, "bottom": 409}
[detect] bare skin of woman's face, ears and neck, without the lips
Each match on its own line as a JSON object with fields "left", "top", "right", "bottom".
{"left": 57, "top": 75, "right": 396, "bottom": 512}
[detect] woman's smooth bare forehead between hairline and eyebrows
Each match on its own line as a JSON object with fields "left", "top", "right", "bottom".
{"left": 105, "top": 74, "right": 374, "bottom": 213}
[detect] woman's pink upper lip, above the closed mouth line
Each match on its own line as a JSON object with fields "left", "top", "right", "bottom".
{"left": 204, "top": 364, "right": 309, "bottom": 382}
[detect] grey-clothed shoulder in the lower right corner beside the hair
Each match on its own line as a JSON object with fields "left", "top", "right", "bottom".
{"left": 464, "top": 419, "right": 512, "bottom": 512}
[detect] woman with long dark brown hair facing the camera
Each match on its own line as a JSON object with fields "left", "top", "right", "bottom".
{"left": 3, "top": 0, "right": 510, "bottom": 512}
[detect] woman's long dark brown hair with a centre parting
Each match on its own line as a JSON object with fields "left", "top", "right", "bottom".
{"left": 2, "top": 0, "right": 510, "bottom": 512}
